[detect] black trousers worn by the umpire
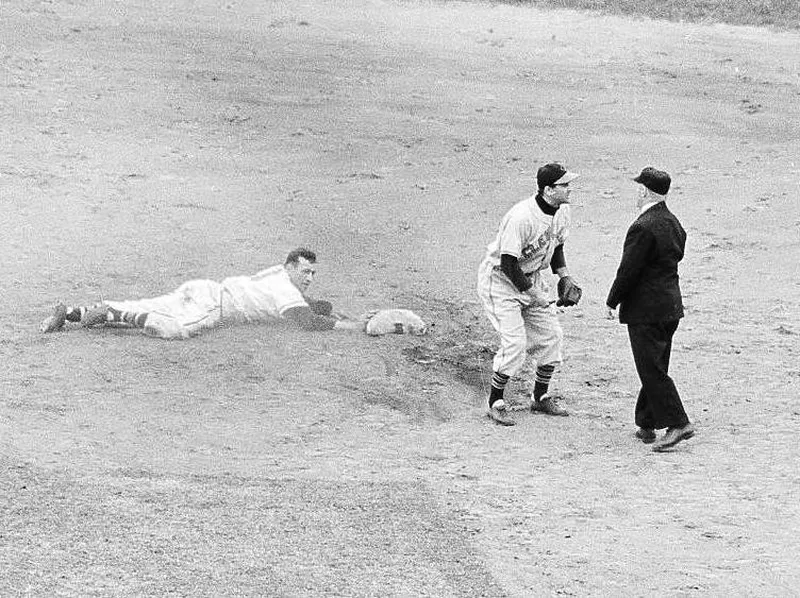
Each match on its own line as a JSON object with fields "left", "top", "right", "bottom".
{"left": 628, "top": 320, "right": 689, "bottom": 430}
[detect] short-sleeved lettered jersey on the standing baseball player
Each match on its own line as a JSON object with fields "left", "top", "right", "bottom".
{"left": 484, "top": 197, "right": 572, "bottom": 275}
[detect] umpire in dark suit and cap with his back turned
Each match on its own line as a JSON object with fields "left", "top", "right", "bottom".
{"left": 606, "top": 166, "right": 694, "bottom": 452}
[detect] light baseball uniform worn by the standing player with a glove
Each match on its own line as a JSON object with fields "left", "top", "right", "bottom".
{"left": 478, "top": 196, "right": 571, "bottom": 376}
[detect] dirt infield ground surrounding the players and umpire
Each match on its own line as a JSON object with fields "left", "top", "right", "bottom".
{"left": 0, "top": 0, "right": 800, "bottom": 596}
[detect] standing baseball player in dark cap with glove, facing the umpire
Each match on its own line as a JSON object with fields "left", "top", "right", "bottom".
{"left": 478, "top": 163, "right": 581, "bottom": 426}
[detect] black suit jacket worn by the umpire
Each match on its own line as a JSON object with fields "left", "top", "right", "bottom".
{"left": 606, "top": 201, "right": 686, "bottom": 324}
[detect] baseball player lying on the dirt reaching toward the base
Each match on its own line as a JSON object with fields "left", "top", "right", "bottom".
{"left": 41, "top": 247, "right": 372, "bottom": 339}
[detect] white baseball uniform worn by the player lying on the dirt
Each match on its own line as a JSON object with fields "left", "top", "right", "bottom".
{"left": 107, "top": 266, "right": 308, "bottom": 338}
